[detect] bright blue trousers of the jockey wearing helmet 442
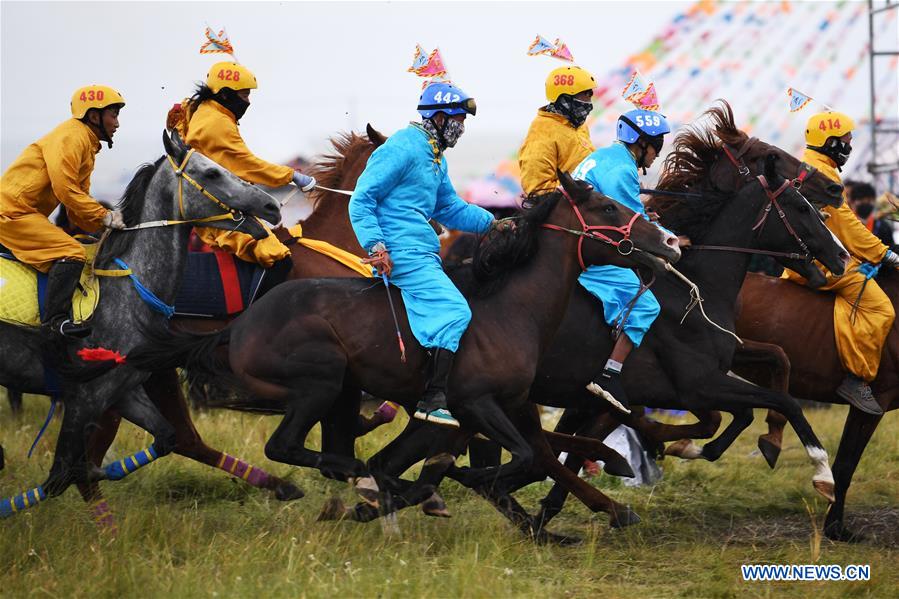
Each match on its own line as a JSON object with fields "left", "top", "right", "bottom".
{"left": 389, "top": 252, "right": 471, "bottom": 352}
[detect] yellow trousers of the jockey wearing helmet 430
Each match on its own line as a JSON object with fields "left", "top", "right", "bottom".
{"left": 0, "top": 212, "right": 86, "bottom": 272}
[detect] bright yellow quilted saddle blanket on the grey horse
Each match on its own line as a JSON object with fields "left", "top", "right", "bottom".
{"left": 0, "top": 243, "right": 100, "bottom": 326}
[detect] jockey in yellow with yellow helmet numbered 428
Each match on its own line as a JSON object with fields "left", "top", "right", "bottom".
{"left": 173, "top": 62, "right": 315, "bottom": 297}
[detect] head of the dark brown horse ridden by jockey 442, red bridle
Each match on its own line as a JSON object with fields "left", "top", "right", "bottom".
{"left": 557, "top": 171, "right": 681, "bottom": 270}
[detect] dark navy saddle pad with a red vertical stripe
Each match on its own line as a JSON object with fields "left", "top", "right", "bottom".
{"left": 175, "top": 251, "right": 265, "bottom": 318}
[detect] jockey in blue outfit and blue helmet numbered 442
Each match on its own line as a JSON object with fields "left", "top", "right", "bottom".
{"left": 349, "top": 82, "right": 493, "bottom": 426}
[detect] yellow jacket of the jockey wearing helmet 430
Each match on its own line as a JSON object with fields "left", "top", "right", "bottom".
{"left": 0, "top": 119, "right": 108, "bottom": 231}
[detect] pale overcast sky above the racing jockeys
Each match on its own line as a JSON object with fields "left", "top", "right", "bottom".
{"left": 0, "top": 1, "right": 691, "bottom": 199}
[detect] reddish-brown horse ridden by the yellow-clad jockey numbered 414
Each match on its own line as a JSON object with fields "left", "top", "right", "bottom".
{"left": 737, "top": 271, "right": 899, "bottom": 540}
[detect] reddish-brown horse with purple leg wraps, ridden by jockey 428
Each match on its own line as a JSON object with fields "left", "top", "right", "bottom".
{"left": 70, "top": 125, "right": 386, "bottom": 522}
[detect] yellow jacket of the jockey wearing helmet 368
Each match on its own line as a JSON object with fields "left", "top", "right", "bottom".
{"left": 518, "top": 110, "right": 596, "bottom": 194}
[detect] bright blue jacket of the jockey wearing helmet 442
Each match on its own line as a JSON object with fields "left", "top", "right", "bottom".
{"left": 349, "top": 125, "right": 493, "bottom": 253}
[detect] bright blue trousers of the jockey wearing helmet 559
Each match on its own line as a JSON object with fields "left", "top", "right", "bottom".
{"left": 578, "top": 266, "right": 661, "bottom": 346}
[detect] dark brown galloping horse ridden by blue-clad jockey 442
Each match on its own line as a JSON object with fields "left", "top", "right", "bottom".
{"left": 129, "top": 174, "right": 680, "bottom": 516}
